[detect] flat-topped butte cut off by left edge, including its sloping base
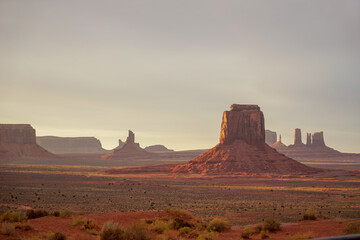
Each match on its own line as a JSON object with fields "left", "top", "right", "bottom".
{"left": 0, "top": 124, "right": 57, "bottom": 159}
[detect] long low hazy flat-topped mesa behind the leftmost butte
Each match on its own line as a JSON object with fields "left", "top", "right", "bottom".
{"left": 36, "top": 136, "right": 109, "bottom": 154}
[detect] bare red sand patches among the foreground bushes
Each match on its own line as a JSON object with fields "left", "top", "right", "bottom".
{"left": 0, "top": 212, "right": 360, "bottom": 240}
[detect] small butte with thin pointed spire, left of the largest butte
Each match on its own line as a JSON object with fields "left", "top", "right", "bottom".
{"left": 101, "top": 130, "right": 155, "bottom": 160}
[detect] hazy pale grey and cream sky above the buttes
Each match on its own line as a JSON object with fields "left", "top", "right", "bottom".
{"left": 0, "top": 0, "right": 360, "bottom": 152}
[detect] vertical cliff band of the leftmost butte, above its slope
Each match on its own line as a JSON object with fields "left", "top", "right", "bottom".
{"left": 0, "top": 124, "right": 36, "bottom": 144}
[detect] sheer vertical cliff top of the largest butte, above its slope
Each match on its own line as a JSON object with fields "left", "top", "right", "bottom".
{"left": 220, "top": 104, "right": 265, "bottom": 145}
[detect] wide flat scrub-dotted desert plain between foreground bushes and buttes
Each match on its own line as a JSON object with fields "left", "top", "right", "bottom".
{"left": 0, "top": 164, "right": 360, "bottom": 225}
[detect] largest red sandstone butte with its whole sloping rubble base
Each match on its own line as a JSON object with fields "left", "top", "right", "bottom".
{"left": 172, "top": 104, "right": 321, "bottom": 174}
